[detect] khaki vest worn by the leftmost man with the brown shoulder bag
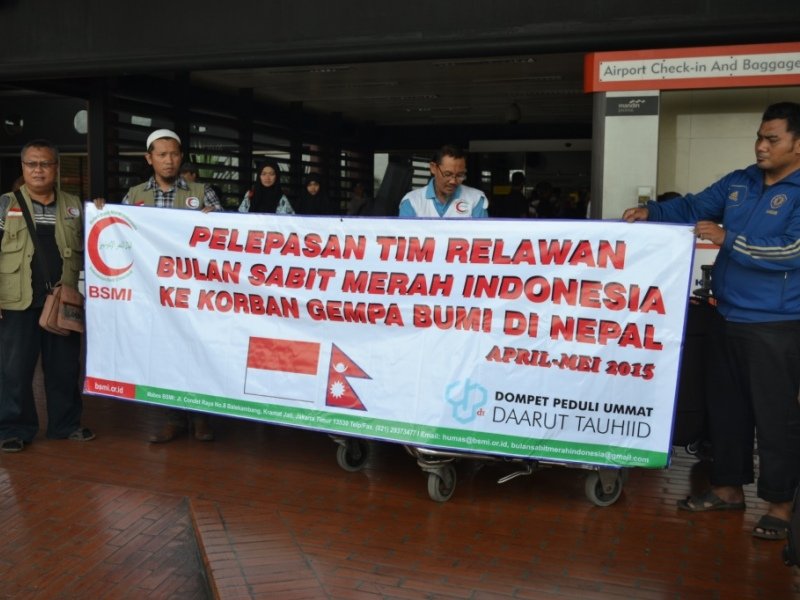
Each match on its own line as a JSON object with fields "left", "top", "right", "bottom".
{"left": 0, "top": 185, "right": 83, "bottom": 310}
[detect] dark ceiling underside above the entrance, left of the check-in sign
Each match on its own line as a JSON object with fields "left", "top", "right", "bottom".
{"left": 192, "top": 53, "right": 592, "bottom": 126}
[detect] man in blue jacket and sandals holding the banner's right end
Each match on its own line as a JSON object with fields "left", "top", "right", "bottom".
{"left": 622, "top": 102, "right": 800, "bottom": 540}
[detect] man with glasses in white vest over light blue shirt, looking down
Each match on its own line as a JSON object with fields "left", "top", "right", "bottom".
{"left": 399, "top": 145, "right": 489, "bottom": 218}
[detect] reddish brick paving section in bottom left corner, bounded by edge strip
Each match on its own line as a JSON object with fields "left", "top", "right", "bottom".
{"left": 0, "top": 472, "right": 208, "bottom": 599}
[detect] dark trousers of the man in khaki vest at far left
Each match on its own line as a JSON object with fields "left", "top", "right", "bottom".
{"left": 0, "top": 308, "right": 83, "bottom": 443}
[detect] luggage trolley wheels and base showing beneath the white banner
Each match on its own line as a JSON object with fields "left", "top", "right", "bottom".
{"left": 331, "top": 436, "right": 628, "bottom": 506}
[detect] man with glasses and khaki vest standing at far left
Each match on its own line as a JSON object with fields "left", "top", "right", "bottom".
{"left": 0, "top": 140, "right": 94, "bottom": 452}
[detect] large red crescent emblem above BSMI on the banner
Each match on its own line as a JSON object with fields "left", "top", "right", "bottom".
{"left": 86, "top": 212, "right": 136, "bottom": 280}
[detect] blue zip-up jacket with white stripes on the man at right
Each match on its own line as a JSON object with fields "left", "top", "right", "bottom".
{"left": 647, "top": 165, "right": 800, "bottom": 323}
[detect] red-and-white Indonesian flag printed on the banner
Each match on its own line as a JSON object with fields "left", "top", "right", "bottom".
{"left": 244, "top": 337, "right": 320, "bottom": 403}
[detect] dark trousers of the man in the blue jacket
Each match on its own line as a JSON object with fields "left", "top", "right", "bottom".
{"left": 708, "top": 314, "right": 800, "bottom": 502}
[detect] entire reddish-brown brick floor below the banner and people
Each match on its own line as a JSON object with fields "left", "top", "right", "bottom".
{"left": 0, "top": 390, "right": 800, "bottom": 600}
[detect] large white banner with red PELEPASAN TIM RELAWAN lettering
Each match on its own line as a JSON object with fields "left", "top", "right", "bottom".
{"left": 84, "top": 204, "right": 694, "bottom": 467}
